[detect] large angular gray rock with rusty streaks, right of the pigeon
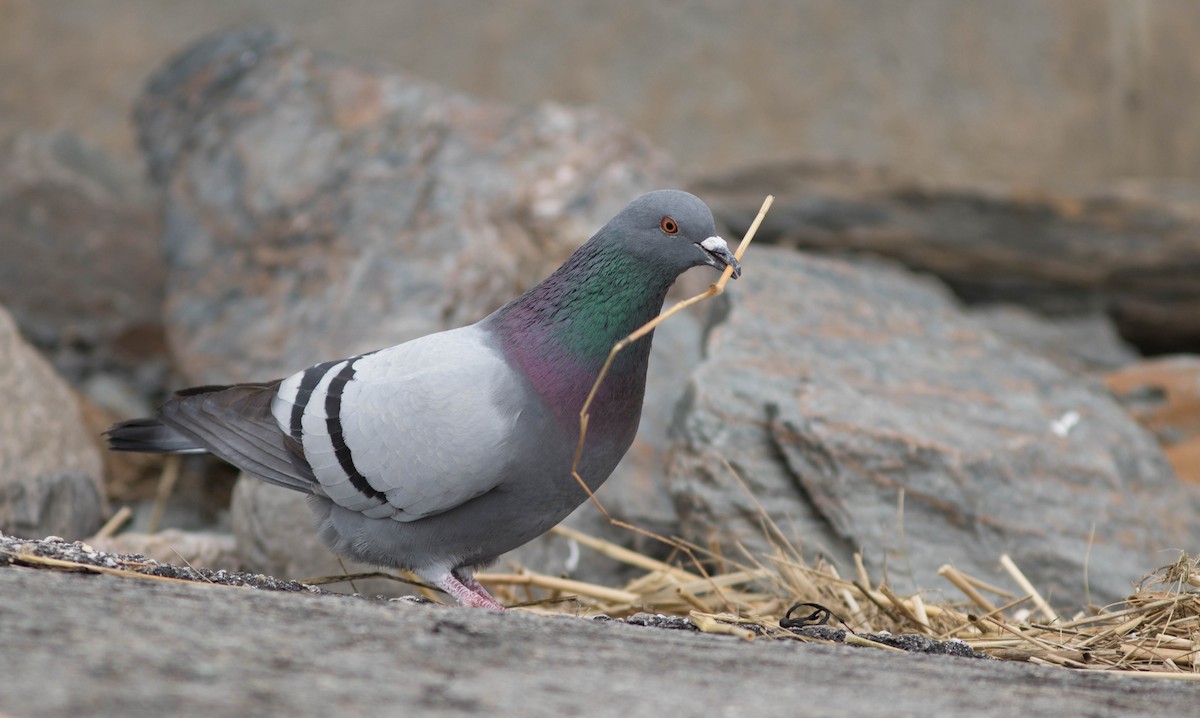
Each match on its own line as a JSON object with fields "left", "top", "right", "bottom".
{"left": 668, "top": 247, "right": 1200, "bottom": 605}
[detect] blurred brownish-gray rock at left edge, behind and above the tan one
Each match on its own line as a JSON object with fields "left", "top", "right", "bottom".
{"left": 0, "top": 132, "right": 166, "bottom": 395}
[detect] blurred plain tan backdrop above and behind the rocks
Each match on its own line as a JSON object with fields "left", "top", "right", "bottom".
{"left": 0, "top": 0, "right": 1200, "bottom": 185}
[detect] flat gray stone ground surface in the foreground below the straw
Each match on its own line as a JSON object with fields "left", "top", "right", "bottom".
{"left": 0, "top": 566, "right": 1200, "bottom": 718}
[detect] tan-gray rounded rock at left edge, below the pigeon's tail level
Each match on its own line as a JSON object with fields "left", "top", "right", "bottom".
{"left": 0, "top": 307, "right": 107, "bottom": 539}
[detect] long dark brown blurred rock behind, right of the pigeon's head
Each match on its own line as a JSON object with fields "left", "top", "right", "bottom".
{"left": 691, "top": 162, "right": 1200, "bottom": 352}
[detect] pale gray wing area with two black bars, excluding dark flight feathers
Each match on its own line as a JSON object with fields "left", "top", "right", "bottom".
{"left": 272, "top": 325, "right": 523, "bottom": 521}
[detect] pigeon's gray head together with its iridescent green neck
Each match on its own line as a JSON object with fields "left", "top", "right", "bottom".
{"left": 485, "top": 190, "right": 740, "bottom": 427}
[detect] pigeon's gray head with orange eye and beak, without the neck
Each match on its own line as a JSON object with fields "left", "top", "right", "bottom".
{"left": 596, "top": 190, "right": 742, "bottom": 279}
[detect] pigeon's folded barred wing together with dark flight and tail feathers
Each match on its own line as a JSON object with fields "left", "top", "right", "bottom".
{"left": 110, "top": 325, "right": 529, "bottom": 521}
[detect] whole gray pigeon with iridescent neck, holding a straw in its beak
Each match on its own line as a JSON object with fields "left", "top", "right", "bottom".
{"left": 106, "top": 190, "right": 742, "bottom": 610}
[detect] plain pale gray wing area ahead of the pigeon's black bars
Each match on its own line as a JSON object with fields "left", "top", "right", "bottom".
{"left": 328, "top": 325, "right": 523, "bottom": 521}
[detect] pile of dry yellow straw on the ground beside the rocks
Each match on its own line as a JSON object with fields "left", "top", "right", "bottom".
{"left": 479, "top": 527, "right": 1200, "bottom": 680}
